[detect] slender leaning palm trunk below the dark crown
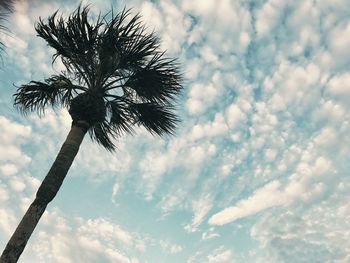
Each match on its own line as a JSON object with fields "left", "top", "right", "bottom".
{"left": 0, "top": 121, "right": 89, "bottom": 263}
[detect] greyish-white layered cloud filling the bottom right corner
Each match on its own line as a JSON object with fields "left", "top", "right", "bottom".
{"left": 251, "top": 190, "right": 350, "bottom": 262}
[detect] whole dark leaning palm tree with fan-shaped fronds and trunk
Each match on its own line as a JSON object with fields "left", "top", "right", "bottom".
{"left": 0, "top": 6, "right": 183, "bottom": 262}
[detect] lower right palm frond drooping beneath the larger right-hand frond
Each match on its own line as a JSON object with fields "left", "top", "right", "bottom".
{"left": 130, "top": 103, "right": 179, "bottom": 136}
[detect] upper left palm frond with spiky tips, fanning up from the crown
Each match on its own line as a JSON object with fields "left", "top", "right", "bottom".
{"left": 35, "top": 5, "right": 102, "bottom": 86}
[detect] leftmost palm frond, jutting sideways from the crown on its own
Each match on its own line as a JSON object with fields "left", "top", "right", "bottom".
{"left": 14, "top": 75, "right": 83, "bottom": 114}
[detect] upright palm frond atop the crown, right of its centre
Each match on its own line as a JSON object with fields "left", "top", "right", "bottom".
{"left": 98, "top": 9, "right": 159, "bottom": 85}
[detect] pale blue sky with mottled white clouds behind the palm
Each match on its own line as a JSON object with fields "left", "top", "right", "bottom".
{"left": 0, "top": 0, "right": 350, "bottom": 263}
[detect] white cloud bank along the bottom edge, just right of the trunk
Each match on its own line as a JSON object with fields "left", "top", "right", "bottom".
{"left": 18, "top": 211, "right": 139, "bottom": 263}
